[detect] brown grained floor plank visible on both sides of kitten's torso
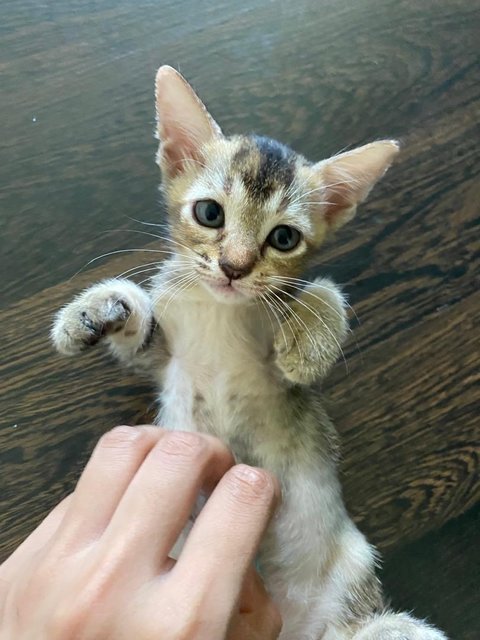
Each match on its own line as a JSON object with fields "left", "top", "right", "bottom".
{"left": 0, "top": 255, "right": 480, "bottom": 549}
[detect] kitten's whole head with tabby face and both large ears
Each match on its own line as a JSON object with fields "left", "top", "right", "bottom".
{"left": 156, "top": 67, "right": 398, "bottom": 302}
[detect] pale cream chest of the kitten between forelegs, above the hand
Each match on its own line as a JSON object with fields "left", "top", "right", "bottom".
{"left": 156, "top": 301, "right": 275, "bottom": 437}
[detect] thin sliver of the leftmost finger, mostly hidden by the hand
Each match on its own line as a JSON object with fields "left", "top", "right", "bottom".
{"left": 0, "top": 495, "right": 72, "bottom": 582}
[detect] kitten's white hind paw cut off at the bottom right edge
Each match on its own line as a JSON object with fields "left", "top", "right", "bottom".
{"left": 352, "top": 612, "right": 447, "bottom": 640}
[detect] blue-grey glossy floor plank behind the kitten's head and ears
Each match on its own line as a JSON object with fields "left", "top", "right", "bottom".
{"left": 0, "top": 0, "right": 479, "bottom": 303}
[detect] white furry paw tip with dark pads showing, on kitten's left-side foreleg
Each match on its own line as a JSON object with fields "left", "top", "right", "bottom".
{"left": 52, "top": 292, "right": 131, "bottom": 355}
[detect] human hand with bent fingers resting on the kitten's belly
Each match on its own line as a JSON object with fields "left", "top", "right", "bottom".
{"left": 0, "top": 426, "right": 281, "bottom": 640}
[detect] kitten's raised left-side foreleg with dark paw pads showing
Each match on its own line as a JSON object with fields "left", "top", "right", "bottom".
{"left": 51, "top": 279, "right": 154, "bottom": 364}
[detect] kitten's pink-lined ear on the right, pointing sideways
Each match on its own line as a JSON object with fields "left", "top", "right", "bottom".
{"left": 313, "top": 140, "right": 400, "bottom": 229}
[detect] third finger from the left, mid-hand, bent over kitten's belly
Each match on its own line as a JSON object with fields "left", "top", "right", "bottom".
{"left": 104, "top": 432, "right": 234, "bottom": 575}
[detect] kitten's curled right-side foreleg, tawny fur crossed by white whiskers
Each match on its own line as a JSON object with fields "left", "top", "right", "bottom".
{"left": 274, "top": 278, "right": 348, "bottom": 384}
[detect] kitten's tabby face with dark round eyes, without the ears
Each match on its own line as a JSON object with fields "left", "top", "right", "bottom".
{"left": 165, "top": 136, "right": 326, "bottom": 302}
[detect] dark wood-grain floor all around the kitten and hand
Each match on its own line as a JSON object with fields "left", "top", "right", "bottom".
{"left": 0, "top": 0, "right": 480, "bottom": 640}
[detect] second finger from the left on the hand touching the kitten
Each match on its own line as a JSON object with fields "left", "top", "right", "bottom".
{"left": 61, "top": 426, "right": 165, "bottom": 546}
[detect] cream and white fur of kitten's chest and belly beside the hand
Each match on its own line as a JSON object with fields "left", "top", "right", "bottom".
{"left": 152, "top": 288, "right": 374, "bottom": 640}
